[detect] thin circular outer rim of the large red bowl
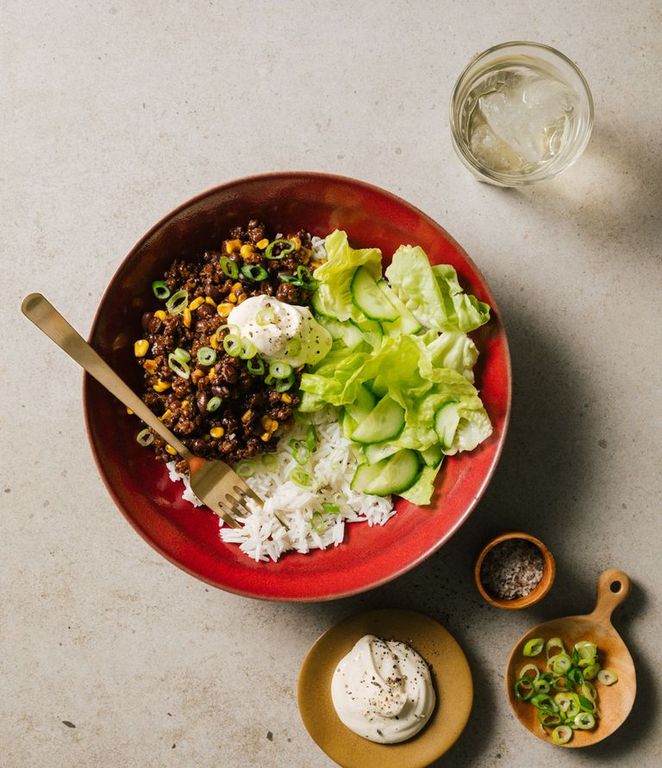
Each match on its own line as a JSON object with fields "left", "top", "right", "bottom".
{"left": 82, "top": 171, "right": 512, "bottom": 603}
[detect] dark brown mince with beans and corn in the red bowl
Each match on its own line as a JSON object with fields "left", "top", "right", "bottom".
{"left": 135, "top": 219, "right": 317, "bottom": 471}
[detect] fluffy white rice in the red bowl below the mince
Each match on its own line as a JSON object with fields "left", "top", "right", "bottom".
{"left": 168, "top": 409, "right": 395, "bottom": 561}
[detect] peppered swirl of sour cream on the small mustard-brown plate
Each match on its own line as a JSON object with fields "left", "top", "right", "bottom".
{"left": 331, "top": 635, "right": 436, "bottom": 744}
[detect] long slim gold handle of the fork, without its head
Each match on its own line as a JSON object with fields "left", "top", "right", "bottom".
{"left": 21, "top": 293, "right": 193, "bottom": 461}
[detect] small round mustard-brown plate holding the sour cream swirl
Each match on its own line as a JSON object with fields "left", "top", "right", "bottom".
{"left": 298, "top": 609, "right": 473, "bottom": 768}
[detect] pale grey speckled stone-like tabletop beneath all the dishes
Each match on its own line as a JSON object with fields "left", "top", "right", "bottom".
{"left": 0, "top": 0, "right": 662, "bottom": 768}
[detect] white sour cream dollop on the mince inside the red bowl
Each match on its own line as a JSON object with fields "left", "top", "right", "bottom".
{"left": 228, "top": 296, "right": 332, "bottom": 368}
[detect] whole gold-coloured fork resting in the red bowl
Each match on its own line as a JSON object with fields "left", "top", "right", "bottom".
{"left": 21, "top": 293, "right": 262, "bottom": 528}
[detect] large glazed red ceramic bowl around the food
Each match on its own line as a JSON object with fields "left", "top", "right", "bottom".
{"left": 84, "top": 173, "right": 511, "bottom": 600}
